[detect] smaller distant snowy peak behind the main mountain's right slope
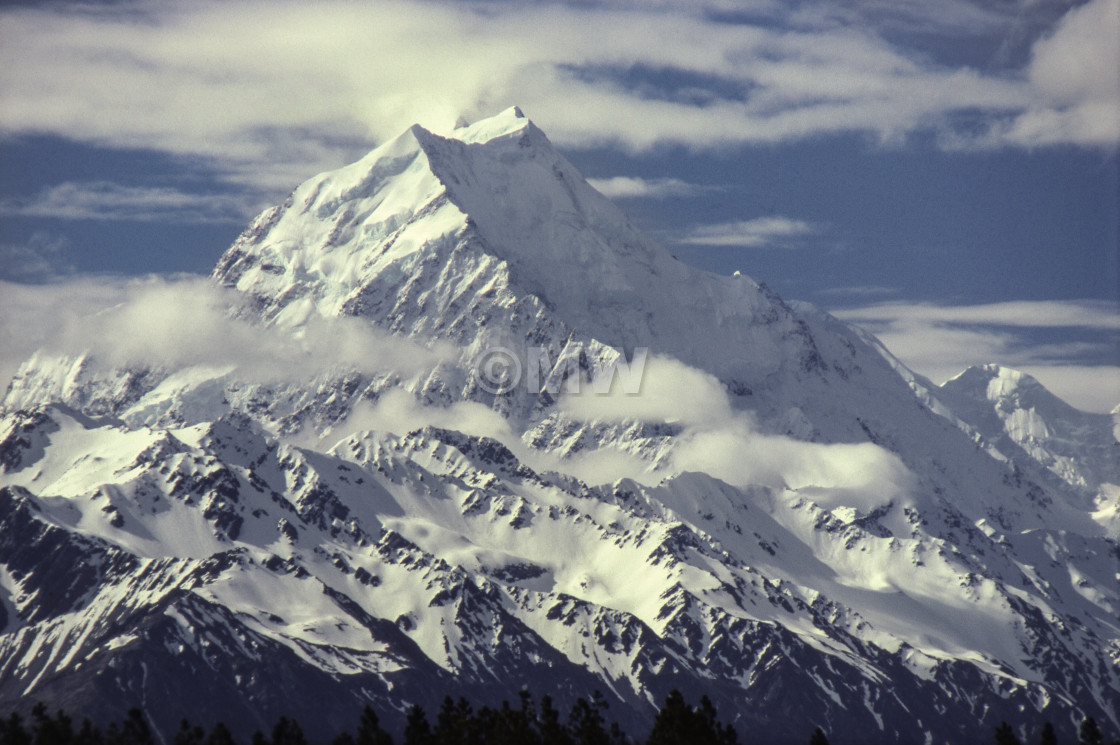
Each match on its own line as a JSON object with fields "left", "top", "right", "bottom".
{"left": 937, "top": 364, "right": 1120, "bottom": 508}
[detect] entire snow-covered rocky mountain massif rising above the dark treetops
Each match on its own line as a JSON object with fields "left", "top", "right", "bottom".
{"left": 0, "top": 110, "right": 1120, "bottom": 743}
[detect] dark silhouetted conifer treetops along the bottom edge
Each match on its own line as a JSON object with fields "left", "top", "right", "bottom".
{"left": 0, "top": 690, "right": 1120, "bottom": 745}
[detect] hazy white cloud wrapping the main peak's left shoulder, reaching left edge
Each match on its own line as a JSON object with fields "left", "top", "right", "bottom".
{"left": 0, "top": 276, "right": 448, "bottom": 387}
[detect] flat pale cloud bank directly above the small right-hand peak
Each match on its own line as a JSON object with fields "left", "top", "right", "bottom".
{"left": 833, "top": 300, "right": 1120, "bottom": 412}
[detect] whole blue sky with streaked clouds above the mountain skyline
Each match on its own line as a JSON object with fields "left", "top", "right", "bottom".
{"left": 0, "top": 0, "right": 1120, "bottom": 411}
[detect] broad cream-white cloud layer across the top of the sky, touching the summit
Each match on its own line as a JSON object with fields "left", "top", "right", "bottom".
{"left": 0, "top": 0, "right": 1120, "bottom": 192}
